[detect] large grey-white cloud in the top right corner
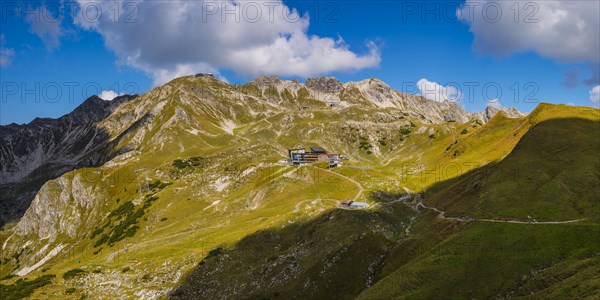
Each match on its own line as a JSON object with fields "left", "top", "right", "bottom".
{"left": 457, "top": 0, "right": 600, "bottom": 62}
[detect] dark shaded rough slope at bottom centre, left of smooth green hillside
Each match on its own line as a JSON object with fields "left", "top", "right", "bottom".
{"left": 172, "top": 205, "right": 414, "bottom": 299}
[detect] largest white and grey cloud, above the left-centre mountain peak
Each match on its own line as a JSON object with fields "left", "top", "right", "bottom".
{"left": 75, "top": 0, "right": 381, "bottom": 84}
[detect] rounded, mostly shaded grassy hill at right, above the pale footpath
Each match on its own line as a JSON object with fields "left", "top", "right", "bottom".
{"left": 425, "top": 105, "right": 600, "bottom": 221}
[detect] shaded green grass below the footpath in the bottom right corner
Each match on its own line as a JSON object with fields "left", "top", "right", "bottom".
{"left": 359, "top": 222, "right": 600, "bottom": 299}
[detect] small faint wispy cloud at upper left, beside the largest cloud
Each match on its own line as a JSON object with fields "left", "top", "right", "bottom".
{"left": 25, "top": 6, "right": 65, "bottom": 51}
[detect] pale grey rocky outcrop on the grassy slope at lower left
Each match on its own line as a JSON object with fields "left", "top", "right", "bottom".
{"left": 1, "top": 173, "right": 107, "bottom": 276}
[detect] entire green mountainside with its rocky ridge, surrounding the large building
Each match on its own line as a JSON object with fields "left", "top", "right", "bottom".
{"left": 0, "top": 77, "right": 600, "bottom": 299}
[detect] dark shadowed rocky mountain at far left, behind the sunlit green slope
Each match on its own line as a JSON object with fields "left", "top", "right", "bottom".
{"left": 0, "top": 95, "right": 136, "bottom": 226}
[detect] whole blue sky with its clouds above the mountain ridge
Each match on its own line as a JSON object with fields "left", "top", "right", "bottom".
{"left": 0, "top": 0, "right": 600, "bottom": 125}
